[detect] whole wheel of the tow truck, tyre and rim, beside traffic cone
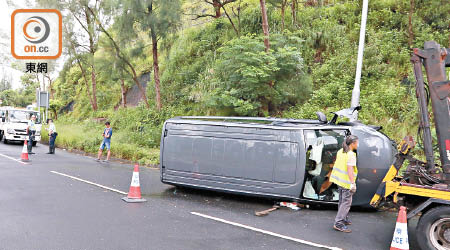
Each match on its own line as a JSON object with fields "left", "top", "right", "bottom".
{"left": 416, "top": 206, "right": 450, "bottom": 250}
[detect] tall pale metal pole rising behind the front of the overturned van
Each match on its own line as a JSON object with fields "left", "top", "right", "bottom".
{"left": 350, "top": 0, "right": 369, "bottom": 121}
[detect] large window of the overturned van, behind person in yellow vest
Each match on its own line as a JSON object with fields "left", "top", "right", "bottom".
{"left": 303, "top": 130, "right": 346, "bottom": 201}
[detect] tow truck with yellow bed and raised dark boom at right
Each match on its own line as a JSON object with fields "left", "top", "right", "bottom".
{"left": 371, "top": 41, "right": 450, "bottom": 250}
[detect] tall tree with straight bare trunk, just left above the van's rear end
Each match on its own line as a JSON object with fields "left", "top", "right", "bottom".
{"left": 110, "top": 0, "right": 181, "bottom": 110}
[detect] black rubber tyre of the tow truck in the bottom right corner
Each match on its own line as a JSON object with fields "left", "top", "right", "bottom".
{"left": 416, "top": 205, "right": 450, "bottom": 250}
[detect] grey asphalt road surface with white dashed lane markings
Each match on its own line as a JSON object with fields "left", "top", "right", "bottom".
{"left": 0, "top": 143, "right": 417, "bottom": 250}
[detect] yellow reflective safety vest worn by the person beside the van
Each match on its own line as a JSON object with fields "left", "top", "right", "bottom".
{"left": 330, "top": 149, "right": 358, "bottom": 189}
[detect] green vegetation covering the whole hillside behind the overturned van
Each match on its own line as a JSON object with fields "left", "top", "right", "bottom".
{"left": 4, "top": 0, "right": 450, "bottom": 163}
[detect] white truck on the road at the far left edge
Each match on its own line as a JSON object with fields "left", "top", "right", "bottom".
{"left": 0, "top": 107, "right": 42, "bottom": 146}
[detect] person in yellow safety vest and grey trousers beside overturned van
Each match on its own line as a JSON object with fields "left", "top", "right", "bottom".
{"left": 330, "top": 135, "right": 358, "bottom": 233}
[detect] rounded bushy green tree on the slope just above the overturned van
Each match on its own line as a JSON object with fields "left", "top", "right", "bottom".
{"left": 206, "top": 35, "right": 311, "bottom": 116}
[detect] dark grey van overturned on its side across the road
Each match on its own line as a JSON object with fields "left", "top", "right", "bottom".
{"left": 160, "top": 112, "right": 396, "bottom": 206}
